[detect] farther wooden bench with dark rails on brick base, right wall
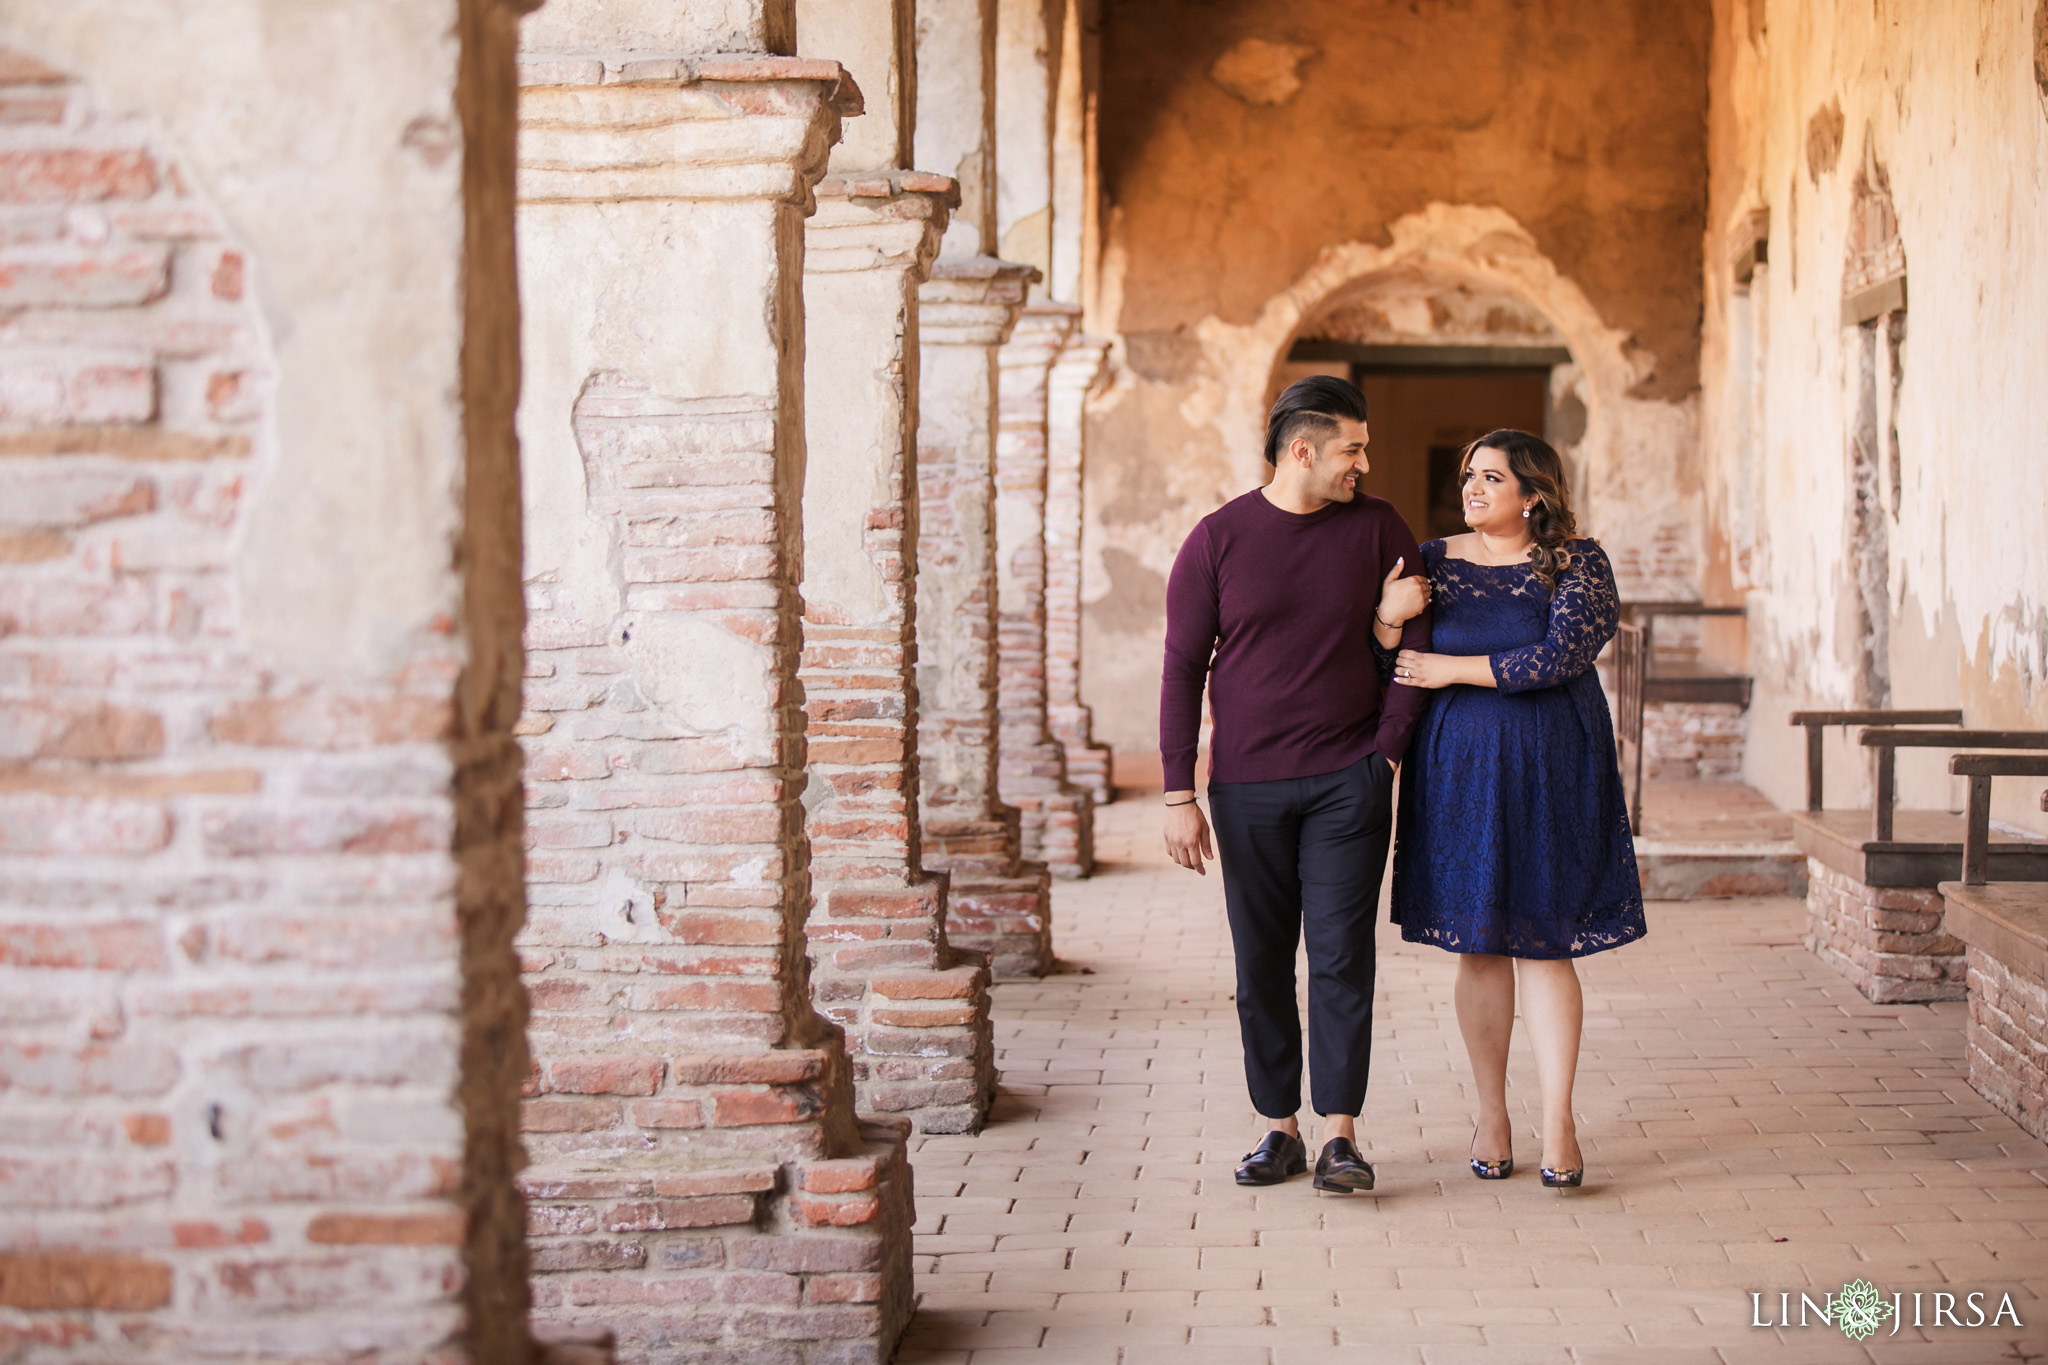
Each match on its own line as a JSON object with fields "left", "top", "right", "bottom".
{"left": 1792, "top": 710, "right": 2048, "bottom": 1003}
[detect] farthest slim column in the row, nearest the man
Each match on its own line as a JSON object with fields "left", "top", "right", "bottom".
{"left": 1044, "top": 336, "right": 1116, "bottom": 804}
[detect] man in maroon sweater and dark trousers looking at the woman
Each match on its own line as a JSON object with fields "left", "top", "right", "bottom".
{"left": 1159, "top": 377, "right": 1430, "bottom": 1191}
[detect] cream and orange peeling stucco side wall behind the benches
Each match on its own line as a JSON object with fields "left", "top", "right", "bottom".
{"left": 1702, "top": 0, "right": 2048, "bottom": 829}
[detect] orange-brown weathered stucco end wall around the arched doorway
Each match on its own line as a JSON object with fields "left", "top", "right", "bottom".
{"left": 1083, "top": 0, "right": 1710, "bottom": 749}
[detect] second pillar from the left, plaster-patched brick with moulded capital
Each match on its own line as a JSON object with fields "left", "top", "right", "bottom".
{"left": 518, "top": 21, "right": 911, "bottom": 1363}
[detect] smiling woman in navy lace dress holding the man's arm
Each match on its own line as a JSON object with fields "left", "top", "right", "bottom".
{"left": 1382, "top": 432, "right": 1645, "bottom": 1187}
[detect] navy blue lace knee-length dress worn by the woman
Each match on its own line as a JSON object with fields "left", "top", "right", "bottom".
{"left": 1393, "top": 540, "right": 1645, "bottom": 958}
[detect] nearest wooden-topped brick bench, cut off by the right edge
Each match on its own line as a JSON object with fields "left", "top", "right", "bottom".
{"left": 1942, "top": 753, "right": 2048, "bottom": 1140}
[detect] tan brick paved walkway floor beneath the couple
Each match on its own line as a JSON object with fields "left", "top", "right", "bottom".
{"left": 899, "top": 800, "right": 2048, "bottom": 1365}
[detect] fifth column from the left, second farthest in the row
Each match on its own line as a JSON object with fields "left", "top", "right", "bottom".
{"left": 995, "top": 303, "right": 1096, "bottom": 878}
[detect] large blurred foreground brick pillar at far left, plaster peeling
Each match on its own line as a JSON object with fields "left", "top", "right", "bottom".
{"left": 0, "top": 0, "right": 532, "bottom": 1365}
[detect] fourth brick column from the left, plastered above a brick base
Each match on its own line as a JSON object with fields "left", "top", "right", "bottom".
{"left": 918, "top": 256, "right": 1053, "bottom": 976}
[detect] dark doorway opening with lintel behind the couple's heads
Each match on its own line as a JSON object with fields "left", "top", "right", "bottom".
{"left": 1288, "top": 340, "right": 1571, "bottom": 540}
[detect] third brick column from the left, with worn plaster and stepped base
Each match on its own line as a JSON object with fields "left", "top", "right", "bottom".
{"left": 801, "top": 170, "right": 995, "bottom": 1134}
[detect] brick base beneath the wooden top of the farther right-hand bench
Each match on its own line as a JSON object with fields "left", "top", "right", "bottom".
{"left": 1806, "top": 857, "right": 1966, "bottom": 1005}
